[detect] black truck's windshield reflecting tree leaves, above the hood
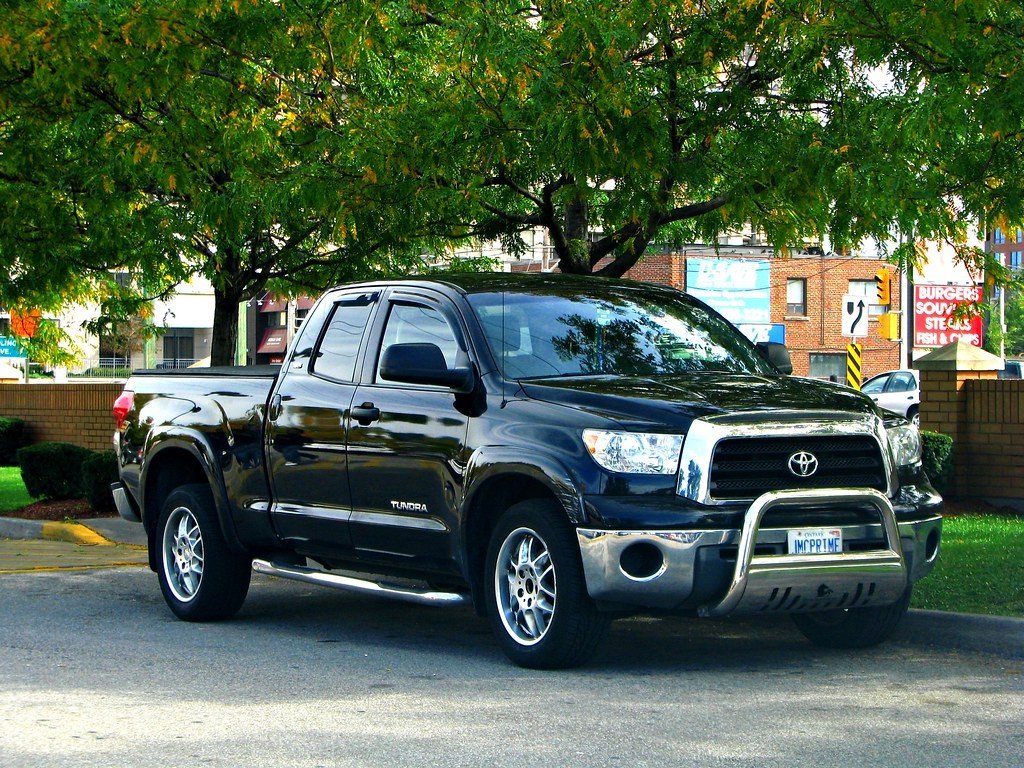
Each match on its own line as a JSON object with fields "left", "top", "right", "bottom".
{"left": 468, "top": 281, "right": 774, "bottom": 379}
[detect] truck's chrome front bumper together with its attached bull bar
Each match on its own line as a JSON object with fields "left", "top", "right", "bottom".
{"left": 577, "top": 488, "right": 942, "bottom": 615}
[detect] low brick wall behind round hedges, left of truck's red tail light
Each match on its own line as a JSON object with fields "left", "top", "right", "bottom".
{"left": 0, "top": 382, "right": 124, "bottom": 451}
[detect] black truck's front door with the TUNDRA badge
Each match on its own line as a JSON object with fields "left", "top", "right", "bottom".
{"left": 348, "top": 291, "right": 468, "bottom": 571}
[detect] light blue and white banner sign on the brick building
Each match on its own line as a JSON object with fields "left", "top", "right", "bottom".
{"left": 686, "top": 257, "right": 777, "bottom": 341}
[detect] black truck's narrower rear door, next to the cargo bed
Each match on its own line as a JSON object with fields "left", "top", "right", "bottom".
{"left": 266, "top": 290, "right": 380, "bottom": 555}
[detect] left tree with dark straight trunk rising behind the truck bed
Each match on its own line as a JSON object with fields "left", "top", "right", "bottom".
{"left": 0, "top": 0, "right": 423, "bottom": 365}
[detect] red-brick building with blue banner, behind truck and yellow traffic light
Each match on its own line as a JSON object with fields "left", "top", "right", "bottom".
{"left": 512, "top": 246, "right": 905, "bottom": 381}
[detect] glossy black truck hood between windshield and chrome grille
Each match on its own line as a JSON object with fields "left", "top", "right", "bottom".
{"left": 520, "top": 373, "right": 877, "bottom": 430}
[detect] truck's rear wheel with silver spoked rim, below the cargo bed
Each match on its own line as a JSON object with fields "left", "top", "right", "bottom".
{"left": 157, "top": 484, "right": 252, "bottom": 622}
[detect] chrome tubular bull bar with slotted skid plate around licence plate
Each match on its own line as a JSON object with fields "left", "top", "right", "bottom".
{"left": 697, "top": 488, "right": 908, "bottom": 616}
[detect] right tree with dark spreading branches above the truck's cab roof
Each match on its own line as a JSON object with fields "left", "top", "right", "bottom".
{"left": 311, "top": 0, "right": 1024, "bottom": 276}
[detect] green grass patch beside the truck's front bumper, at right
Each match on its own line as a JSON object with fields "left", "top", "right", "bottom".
{"left": 910, "top": 514, "right": 1024, "bottom": 616}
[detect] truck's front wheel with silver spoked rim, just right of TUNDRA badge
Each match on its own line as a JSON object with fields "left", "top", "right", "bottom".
{"left": 484, "top": 500, "right": 608, "bottom": 669}
